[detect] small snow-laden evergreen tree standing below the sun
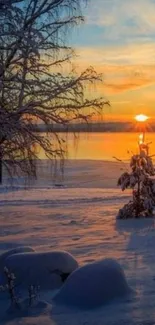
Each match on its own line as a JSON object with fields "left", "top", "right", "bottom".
{"left": 117, "top": 143, "right": 155, "bottom": 219}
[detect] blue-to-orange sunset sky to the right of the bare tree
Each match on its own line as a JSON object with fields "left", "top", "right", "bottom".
{"left": 72, "top": 0, "right": 155, "bottom": 119}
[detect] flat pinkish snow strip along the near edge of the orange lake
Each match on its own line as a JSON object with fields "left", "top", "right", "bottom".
{"left": 3, "top": 159, "right": 129, "bottom": 187}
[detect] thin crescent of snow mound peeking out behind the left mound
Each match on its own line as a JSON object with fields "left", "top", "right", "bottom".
{"left": 0, "top": 246, "right": 35, "bottom": 272}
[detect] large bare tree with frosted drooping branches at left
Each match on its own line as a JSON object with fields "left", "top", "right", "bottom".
{"left": 0, "top": 0, "right": 106, "bottom": 182}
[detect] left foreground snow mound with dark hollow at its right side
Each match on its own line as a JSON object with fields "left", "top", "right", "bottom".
{"left": 2, "top": 251, "right": 78, "bottom": 290}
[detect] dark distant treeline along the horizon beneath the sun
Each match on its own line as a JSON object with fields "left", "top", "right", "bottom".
{"left": 34, "top": 122, "right": 155, "bottom": 132}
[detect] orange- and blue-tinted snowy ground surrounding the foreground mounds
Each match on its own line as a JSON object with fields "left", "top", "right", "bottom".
{"left": 0, "top": 161, "right": 155, "bottom": 325}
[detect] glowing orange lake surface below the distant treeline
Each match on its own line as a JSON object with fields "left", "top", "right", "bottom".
{"left": 39, "top": 132, "right": 155, "bottom": 161}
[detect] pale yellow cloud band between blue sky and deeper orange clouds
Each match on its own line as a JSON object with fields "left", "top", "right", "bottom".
{"left": 77, "top": 42, "right": 155, "bottom": 69}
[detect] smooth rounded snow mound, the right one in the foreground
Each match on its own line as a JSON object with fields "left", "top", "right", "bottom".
{"left": 54, "top": 259, "right": 131, "bottom": 308}
